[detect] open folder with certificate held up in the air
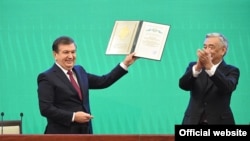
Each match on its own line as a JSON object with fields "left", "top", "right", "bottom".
{"left": 106, "top": 21, "right": 170, "bottom": 60}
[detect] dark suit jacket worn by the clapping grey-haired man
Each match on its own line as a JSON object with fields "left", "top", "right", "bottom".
{"left": 179, "top": 61, "right": 240, "bottom": 124}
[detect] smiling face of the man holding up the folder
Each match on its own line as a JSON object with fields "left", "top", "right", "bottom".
{"left": 53, "top": 43, "right": 76, "bottom": 70}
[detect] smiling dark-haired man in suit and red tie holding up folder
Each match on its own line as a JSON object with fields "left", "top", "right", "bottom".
{"left": 37, "top": 36, "right": 136, "bottom": 134}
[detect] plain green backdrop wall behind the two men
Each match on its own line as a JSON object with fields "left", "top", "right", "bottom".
{"left": 0, "top": 0, "right": 250, "bottom": 134}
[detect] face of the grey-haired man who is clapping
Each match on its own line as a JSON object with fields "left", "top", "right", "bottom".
{"left": 204, "top": 37, "right": 227, "bottom": 63}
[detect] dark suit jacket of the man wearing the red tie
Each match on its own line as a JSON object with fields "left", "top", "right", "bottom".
{"left": 37, "top": 64, "right": 127, "bottom": 134}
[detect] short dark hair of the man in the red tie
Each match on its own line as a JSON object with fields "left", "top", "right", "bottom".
{"left": 52, "top": 36, "right": 76, "bottom": 52}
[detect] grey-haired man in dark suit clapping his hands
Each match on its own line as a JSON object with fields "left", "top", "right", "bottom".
{"left": 179, "top": 33, "right": 240, "bottom": 124}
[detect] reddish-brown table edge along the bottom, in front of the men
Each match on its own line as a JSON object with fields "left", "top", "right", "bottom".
{"left": 0, "top": 134, "right": 174, "bottom": 141}
